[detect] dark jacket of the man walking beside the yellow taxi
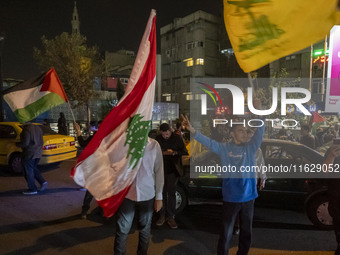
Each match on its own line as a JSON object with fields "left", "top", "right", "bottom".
{"left": 19, "top": 123, "right": 44, "bottom": 159}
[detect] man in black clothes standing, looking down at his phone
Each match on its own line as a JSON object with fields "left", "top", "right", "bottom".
{"left": 156, "top": 123, "right": 188, "bottom": 229}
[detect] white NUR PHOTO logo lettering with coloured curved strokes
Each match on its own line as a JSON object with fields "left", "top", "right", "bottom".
{"left": 197, "top": 82, "right": 312, "bottom": 128}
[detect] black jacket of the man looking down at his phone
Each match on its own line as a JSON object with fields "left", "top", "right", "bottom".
{"left": 156, "top": 133, "right": 188, "bottom": 175}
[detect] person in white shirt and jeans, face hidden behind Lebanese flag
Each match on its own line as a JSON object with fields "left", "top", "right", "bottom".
{"left": 114, "top": 138, "right": 164, "bottom": 255}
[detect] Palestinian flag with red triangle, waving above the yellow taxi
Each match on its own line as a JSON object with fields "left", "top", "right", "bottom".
{"left": 2, "top": 68, "right": 67, "bottom": 123}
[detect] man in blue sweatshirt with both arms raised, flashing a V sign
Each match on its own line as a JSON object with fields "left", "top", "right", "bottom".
{"left": 183, "top": 100, "right": 265, "bottom": 255}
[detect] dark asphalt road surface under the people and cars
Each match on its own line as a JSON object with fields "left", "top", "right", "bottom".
{"left": 0, "top": 160, "right": 335, "bottom": 255}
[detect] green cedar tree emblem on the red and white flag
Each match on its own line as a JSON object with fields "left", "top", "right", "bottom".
{"left": 124, "top": 114, "right": 151, "bottom": 168}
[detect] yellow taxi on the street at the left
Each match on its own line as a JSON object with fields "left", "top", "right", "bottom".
{"left": 0, "top": 122, "right": 77, "bottom": 173}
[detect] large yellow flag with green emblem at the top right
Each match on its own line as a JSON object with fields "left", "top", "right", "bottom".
{"left": 223, "top": 0, "right": 337, "bottom": 72}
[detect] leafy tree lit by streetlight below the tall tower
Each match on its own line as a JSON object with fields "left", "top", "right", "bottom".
{"left": 33, "top": 33, "right": 104, "bottom": 121}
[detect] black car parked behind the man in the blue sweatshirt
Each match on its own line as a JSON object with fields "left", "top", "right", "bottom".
{"left": 176, "top": 139, "right": 333, "bottom": 229}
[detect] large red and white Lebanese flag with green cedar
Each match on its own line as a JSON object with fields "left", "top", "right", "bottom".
{"left": 71, "top": 10, "right": 156, "bottom": 217}
